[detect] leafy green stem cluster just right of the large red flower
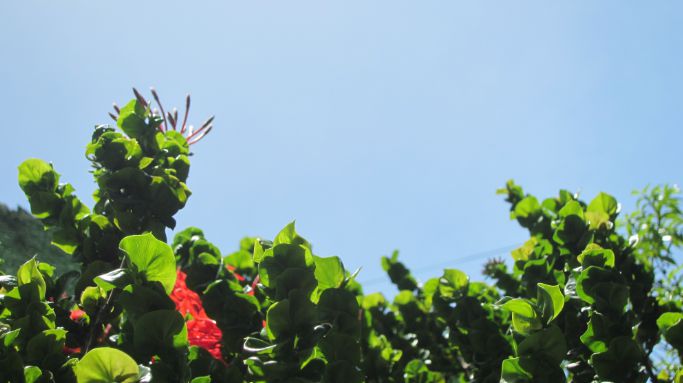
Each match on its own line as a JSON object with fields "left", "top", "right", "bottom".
{"left": 246, "top": 224, "right": 363, "bottom": 382}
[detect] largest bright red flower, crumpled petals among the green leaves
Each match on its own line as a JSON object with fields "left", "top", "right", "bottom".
{"left": 171, "top": 270, "right": 223, "bottom": 360}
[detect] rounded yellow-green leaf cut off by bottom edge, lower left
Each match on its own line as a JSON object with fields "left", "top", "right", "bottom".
{"left": 74, "top": 347, "right": 139, "bottom": 383}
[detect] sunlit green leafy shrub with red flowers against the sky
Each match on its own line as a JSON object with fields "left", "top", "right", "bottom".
{"left": 0, "top": 92, "right": 683, "bottom": 383}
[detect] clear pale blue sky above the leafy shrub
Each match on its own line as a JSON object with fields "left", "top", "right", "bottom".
{"left": 0, "top": 0, "right": 683, "bottom": 291}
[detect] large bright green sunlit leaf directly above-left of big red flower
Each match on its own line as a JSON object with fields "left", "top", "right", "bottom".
{"left": 119, "top": 233, "right": 176, "bottom": 294}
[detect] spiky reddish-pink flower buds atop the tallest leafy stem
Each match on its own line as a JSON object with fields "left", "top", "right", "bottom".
{"left": 109, "top": 88, "right": 214, "bottom": 145}
